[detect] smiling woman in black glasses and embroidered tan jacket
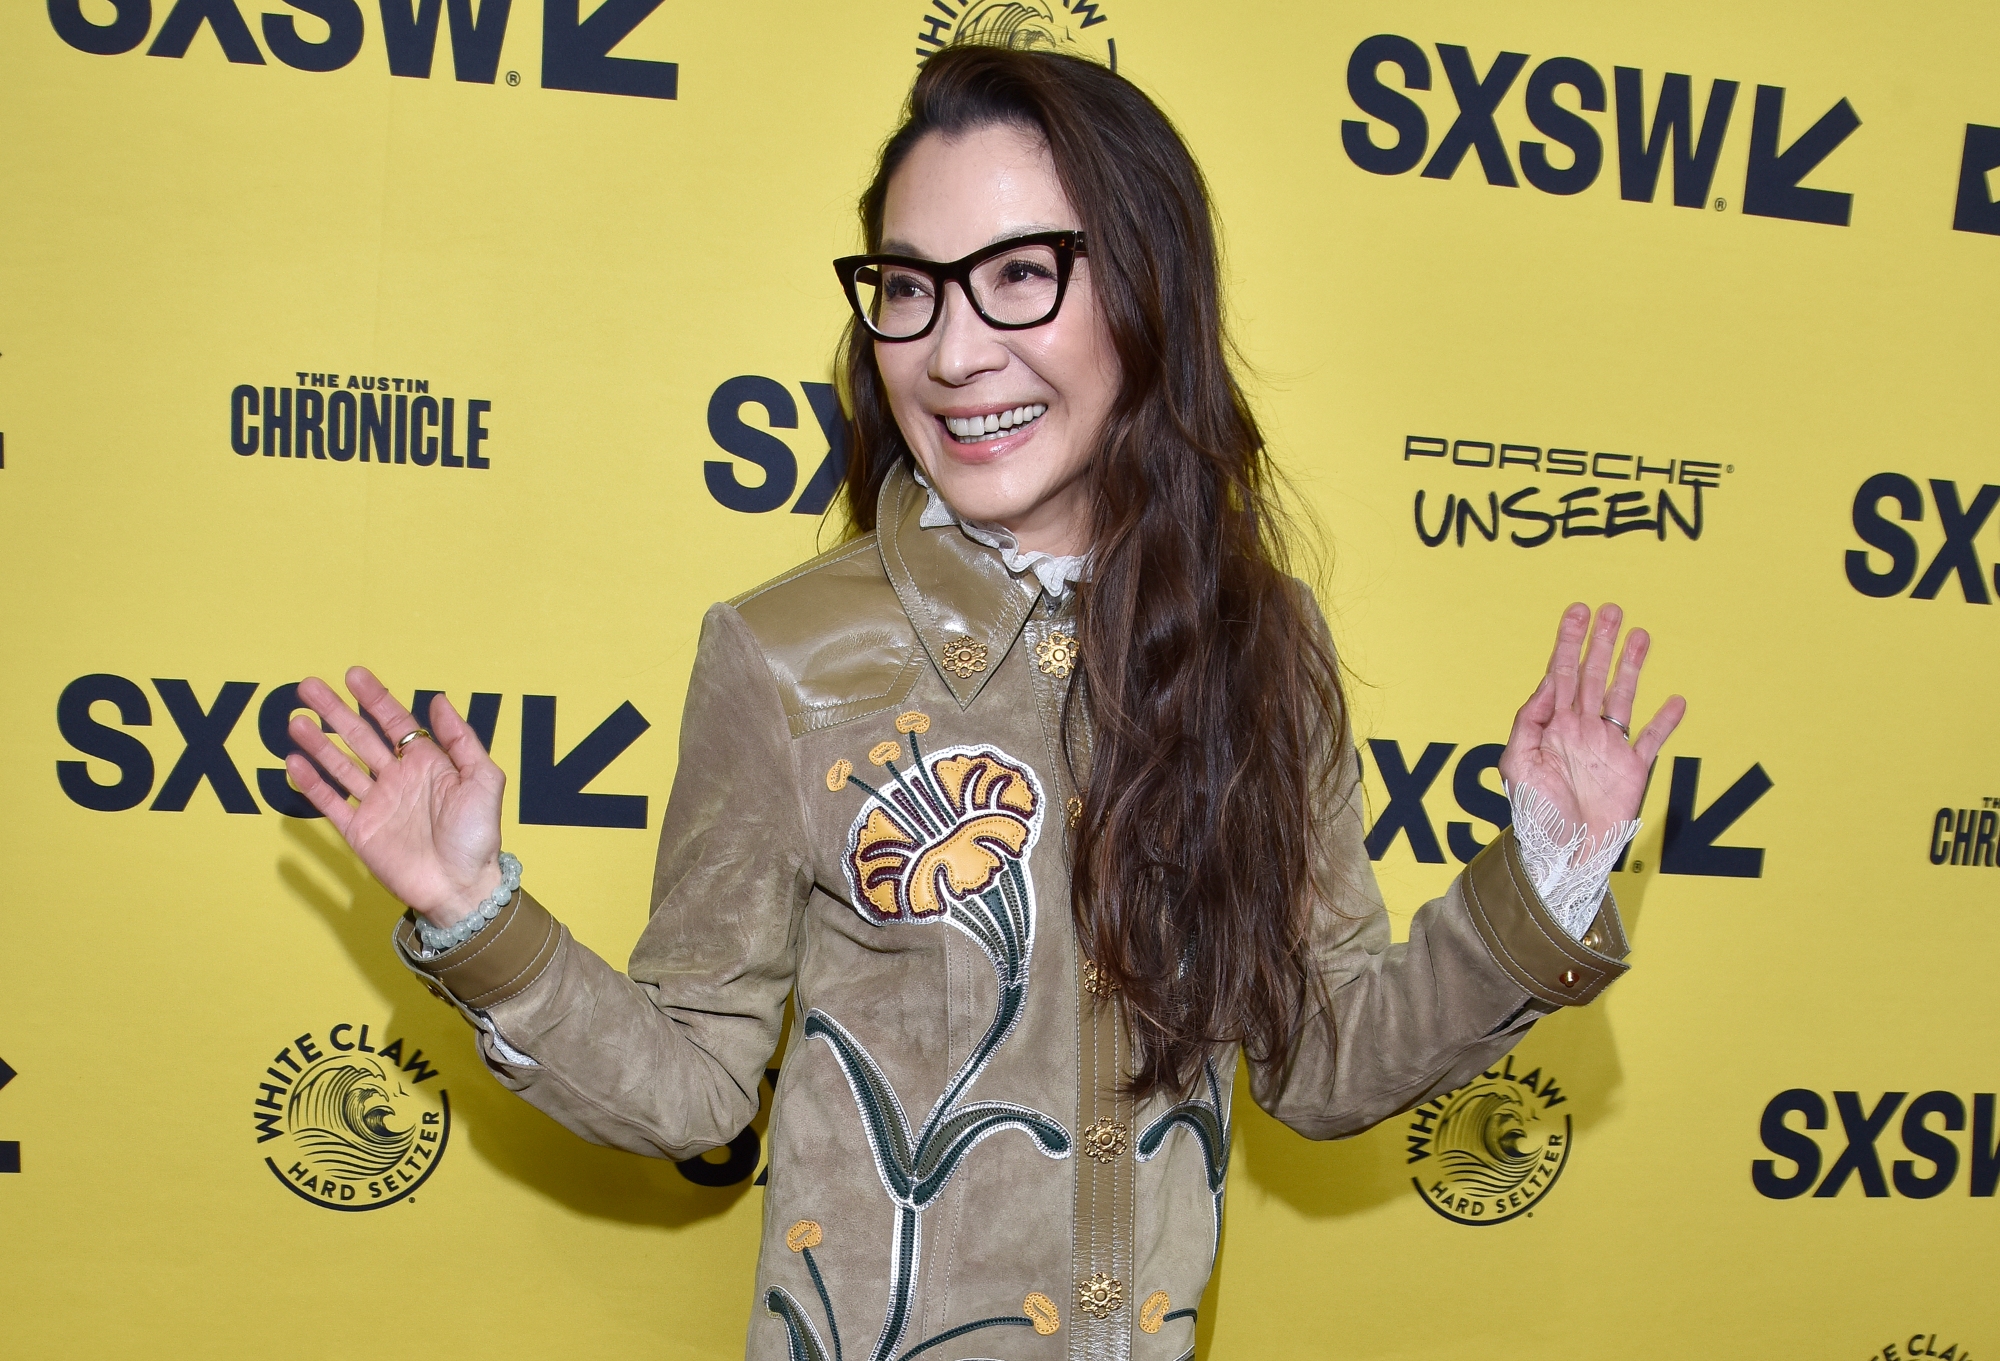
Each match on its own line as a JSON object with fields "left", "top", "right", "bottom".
{"left": 288, "top": 46, "right": 1682, "bottom": 1361}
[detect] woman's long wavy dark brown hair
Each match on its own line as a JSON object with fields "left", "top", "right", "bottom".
{"left": 842, "top": 46, "right": 1344, "bottom": 1099}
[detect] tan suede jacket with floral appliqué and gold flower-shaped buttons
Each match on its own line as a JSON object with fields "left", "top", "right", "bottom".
{"left": 398, "top": 460, "right": 1626, "bottom": 1361}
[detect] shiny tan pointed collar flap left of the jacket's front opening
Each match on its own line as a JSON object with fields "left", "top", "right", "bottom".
{"left": 876, "top": 462, "right": 1040, "bottom": 709}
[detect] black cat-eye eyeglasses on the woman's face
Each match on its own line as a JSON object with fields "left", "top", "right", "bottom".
{"left": 834, "top": 232, "right": 1084, "bottom": 340}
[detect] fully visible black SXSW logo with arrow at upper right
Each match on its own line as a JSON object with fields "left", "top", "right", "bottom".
{"left": 1340, "top": 34, "right": 1862, "bottom": 226}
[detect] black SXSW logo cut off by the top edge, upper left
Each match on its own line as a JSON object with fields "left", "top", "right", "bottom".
{"left": 48, "top": 0, "right": 680, "bottom": 100}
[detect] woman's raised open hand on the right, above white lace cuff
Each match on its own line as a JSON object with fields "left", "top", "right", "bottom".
{"left": 1500, "top": 604, "right": 1688, "bottom": 841}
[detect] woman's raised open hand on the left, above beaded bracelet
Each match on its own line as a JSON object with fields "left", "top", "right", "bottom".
{"left": 284, "top": 666, "right": 506, "bottom": 927}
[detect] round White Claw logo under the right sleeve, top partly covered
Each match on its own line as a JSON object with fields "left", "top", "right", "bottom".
{"left": 1404, "top": 1055, "right": 1570, "bottom": 1225}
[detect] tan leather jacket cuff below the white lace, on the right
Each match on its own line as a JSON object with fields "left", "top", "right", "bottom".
{"left": 1464, "top": 829, "right": 1630, "bottom": 1007}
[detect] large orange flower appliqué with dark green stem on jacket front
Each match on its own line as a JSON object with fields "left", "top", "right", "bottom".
{"left": 764, "top": 713, "right": 1072, "bottom": 1361}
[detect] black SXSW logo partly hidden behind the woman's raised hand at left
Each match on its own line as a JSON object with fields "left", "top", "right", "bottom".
{"left": 56, "top": 672, "right": 652, "bottom": 827}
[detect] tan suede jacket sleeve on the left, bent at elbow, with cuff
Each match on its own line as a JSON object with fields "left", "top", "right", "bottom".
{"left": 396, "top": 604, "right": 810, "bottom": 1159}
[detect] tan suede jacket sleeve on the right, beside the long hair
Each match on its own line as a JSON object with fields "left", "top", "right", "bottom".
{"left": 1250, "top": 612, "right": 1628, "bottom": 1139}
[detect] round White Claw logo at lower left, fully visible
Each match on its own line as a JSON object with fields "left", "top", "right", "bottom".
{"left": 250, "top": 1021, "right": 452, "bottom": 1211}
